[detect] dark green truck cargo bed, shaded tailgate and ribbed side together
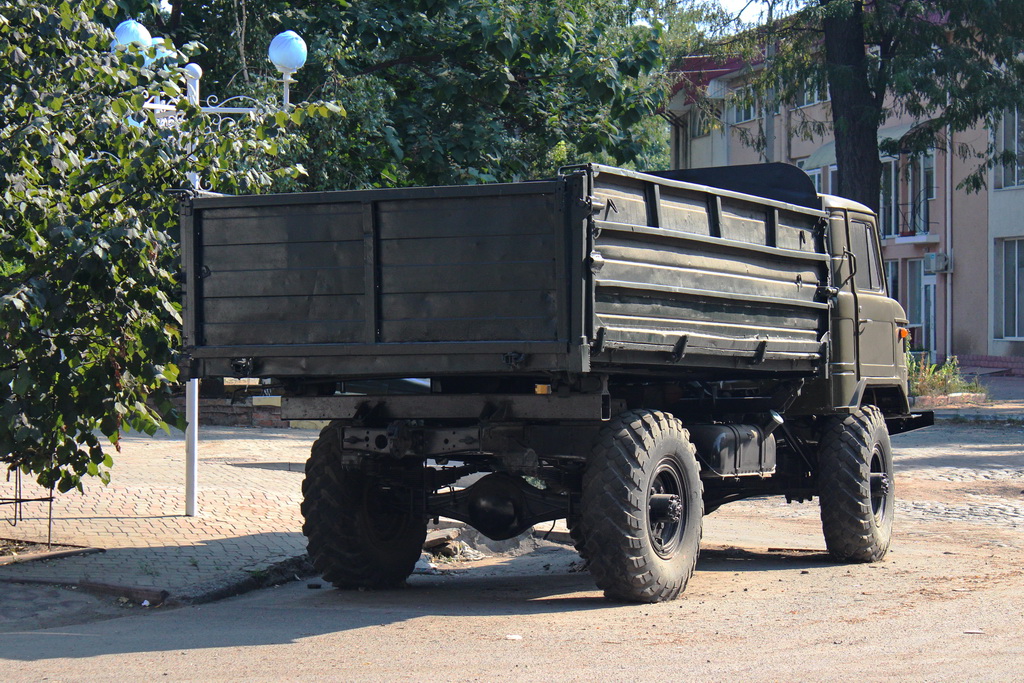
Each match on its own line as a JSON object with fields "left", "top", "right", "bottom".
{"left": 181, "top": 165, "right": 829, "bottom": 379}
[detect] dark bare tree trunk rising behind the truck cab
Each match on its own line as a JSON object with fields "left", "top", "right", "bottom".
{"left": 819, "top": 0, "right": 883, "bottom": 211}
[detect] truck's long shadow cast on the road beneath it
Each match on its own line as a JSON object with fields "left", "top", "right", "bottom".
{"left": 0, "top": 547, "right": 856, "bottom": 661}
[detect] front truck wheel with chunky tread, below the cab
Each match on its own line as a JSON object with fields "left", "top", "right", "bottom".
{"left": 818, "top": 405, "right": 896, "bottom": 562}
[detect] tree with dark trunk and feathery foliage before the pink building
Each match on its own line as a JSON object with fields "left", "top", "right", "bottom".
{"left": 692, "top": 0, "right": 1024, "bottom": 209}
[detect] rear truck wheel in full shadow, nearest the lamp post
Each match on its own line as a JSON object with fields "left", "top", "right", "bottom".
{"left": 302, "top": 425, "right": 427, "bottom": 588}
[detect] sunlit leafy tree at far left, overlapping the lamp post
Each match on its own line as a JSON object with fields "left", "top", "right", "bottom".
{"left": 0, "top": 0, "right": 319, "bottom": 492}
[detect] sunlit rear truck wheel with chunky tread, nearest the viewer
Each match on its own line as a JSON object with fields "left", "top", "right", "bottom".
{"left": 581, "top": 411, "right": 703, "bottom": 602}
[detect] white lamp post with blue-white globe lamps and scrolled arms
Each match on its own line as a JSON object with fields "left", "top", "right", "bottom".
{"left": 111, "top": 19, "right": 306, "bottom": 517}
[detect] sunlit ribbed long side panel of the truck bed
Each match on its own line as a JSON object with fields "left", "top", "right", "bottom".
{"left": 591, "top": 170, "right": 828, "bottom": 372}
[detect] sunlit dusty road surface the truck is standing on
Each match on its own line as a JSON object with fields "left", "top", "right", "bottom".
{"left": 0, "top": 426, "right": 1024, "bottom": 681}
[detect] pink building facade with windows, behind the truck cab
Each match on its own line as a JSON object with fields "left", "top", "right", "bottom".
{"left": 666, "top": 62, "right": 1024, "bottom": 375}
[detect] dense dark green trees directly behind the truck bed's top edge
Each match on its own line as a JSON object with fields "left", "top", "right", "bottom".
{"left": 148, "top": 0, "right": 665, "bottom": 189}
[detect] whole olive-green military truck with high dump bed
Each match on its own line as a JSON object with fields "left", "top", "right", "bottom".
{"left": 181, "top": 164, "right": 931, "bottom": 602}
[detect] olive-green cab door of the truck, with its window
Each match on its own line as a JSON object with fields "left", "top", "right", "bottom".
{"left": 847, "top": 213, "right": 896, "bottom": 379}
